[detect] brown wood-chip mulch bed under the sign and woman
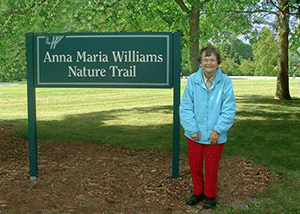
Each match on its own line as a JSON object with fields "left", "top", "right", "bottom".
{"left": 0, "top": 124, "right": 271, "bottom": 213}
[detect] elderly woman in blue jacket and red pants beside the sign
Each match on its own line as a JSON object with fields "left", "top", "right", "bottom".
{"left": 180, "top": 47, "right": 236, "bottom": 209}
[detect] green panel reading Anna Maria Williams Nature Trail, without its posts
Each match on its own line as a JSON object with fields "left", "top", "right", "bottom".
{"left": 34, "top": 33, "right": 173, "bottom": 88}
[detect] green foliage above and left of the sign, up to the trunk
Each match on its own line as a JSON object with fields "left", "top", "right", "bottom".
{"left": 0, "top": 0, "right": 186, "bottom": 81}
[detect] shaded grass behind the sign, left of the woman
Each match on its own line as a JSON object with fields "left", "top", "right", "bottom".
{"left": 9, "top": 105, "right": 180, "bottom": 150}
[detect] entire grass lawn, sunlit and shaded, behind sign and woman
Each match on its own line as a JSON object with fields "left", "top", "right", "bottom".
{"left": 0, "top": 80, "right": 300, "bottom": 213}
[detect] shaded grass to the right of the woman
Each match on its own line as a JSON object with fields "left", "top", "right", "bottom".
{"left": 224, "top": 96, "right": 300, "bottom": 170}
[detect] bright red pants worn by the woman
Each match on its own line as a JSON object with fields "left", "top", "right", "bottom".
{"left": 188, "top": 139, "right": 225, "bottom": 198}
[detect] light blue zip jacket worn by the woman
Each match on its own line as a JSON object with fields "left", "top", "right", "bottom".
{"left": 180, "top": 67, "right": 236, "bottom": 144}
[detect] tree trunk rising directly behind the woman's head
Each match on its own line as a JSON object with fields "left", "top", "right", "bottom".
{"left": 189, "top": 6, "right": 200, "bottom": 73}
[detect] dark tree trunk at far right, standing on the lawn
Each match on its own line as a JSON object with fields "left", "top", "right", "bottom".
{"left": 275, "top": 0, "right": 291, "bottom": 100}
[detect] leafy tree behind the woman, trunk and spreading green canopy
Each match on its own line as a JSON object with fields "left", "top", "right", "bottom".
{"left": 92, "top": 0, "right": 253, "bottom": 73}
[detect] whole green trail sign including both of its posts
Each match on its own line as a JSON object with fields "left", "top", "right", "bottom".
{"left": 27, "top": 32, "right": 181, "bottom": 180}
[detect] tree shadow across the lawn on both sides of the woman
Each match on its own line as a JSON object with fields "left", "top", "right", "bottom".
{"left": 7, "top": 96, "right": 300, "bottom": 170}
